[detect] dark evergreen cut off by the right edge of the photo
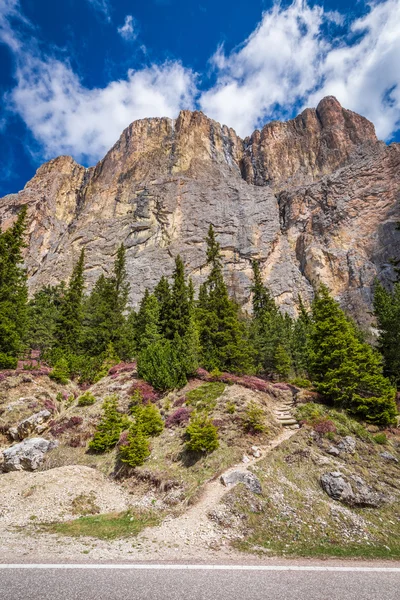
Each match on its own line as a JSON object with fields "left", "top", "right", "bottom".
{"left": 374, "top": 282, "right": 400, "bottom": 387}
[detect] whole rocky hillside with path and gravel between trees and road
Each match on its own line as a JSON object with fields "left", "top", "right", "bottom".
{"left": 0, "top": 365, "right": 400, "bottom": 560}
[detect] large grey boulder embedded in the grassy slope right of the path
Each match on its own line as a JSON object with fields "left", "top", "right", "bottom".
{"left": 320, "top": 471, "right": 388, "bottom": 508}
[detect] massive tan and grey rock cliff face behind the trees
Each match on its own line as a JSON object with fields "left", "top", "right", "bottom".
{"left": 0, "top": 97, "right": 400, "bottom": 318}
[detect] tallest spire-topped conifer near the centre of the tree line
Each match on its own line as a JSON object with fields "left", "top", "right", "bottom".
{"left": 197, "top": 225, "right": 253, "bottom": 373}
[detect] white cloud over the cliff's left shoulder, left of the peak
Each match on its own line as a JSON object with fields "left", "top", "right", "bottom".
{"left": 10, "top": 57, "right": 195, "bottom": 163}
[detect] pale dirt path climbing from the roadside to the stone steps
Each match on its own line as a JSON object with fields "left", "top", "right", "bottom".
{"left": 139, "top": 428, "right": 297, "bottom": 554}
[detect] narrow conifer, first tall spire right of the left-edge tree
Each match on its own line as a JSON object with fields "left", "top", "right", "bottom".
{"left": 56, "top": 249, "right": 85, "bottom": 353}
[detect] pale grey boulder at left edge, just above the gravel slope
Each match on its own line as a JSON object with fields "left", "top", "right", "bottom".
{"left": 2, "top": 438, "right": 58, "bottom": 473}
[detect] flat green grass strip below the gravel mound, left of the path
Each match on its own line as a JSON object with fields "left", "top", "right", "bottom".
{"left": 38, "top": 511, "right": 161, "bottom": 540}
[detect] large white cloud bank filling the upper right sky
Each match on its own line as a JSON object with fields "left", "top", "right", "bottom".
{"left": 200, "top": 0, "right": 400, "bottom": 139}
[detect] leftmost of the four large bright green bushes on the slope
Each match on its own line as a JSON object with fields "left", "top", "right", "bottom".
{"left": 89, "top": 396, "right": 131, "bottom": 452}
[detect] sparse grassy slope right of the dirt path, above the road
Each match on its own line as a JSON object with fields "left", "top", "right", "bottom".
{"left": 225, "top": 424, "right": 400, "bottom": 559}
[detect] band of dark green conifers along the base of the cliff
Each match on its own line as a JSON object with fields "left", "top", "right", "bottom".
{"left": 0, "top": 208, "right": 400, "bottom": 425}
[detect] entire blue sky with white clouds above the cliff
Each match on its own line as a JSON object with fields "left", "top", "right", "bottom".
{"left": 0, "top": 0, "right": 400, "bottom": 196}
